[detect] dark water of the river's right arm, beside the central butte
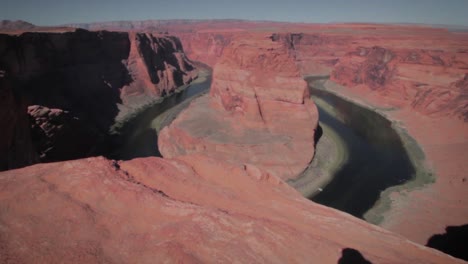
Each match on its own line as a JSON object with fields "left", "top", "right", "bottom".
{"left": 306, "top": 78, "right": 416, "bottom": 223}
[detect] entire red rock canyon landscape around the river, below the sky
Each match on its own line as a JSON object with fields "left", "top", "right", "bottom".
{"left": 0, "top": 20, "right": 468, "bottom": 263}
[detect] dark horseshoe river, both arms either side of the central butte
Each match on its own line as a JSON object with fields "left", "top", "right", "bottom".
{"left": 110, "top": 74, "right": 415, "bottom": 225}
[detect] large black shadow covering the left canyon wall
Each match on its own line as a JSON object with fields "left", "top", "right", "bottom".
{"left": 0, "top": 30, "right": 132, "bottom": 170}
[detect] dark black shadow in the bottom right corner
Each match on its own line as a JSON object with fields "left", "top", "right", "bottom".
{"left": 426, "top": 224, "right": 468, "bottom": 261}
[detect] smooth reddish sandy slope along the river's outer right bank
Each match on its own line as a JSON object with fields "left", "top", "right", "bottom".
{"left": 308, "top": 75, "right": 468, "bottom": 244}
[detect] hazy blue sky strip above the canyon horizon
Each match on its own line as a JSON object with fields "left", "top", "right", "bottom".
{"left": 0, "top": 0, "right": 468, "bottom": 26}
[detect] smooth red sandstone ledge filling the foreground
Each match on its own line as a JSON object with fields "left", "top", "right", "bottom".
{"left": 0, "top": 155, "right": 461, "bottom": 263}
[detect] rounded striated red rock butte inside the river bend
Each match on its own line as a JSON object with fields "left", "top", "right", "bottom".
{"left": 158, "top": 36, "right": 318, "bottom": 179}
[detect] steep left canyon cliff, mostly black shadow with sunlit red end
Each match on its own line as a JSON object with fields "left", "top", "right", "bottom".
{"left": 0, "top": 30, "right": 196, "bottom": 169}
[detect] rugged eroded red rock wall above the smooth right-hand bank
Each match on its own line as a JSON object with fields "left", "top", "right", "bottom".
{"left": 331, "top": 46, "right": 468, "bottom": 121}
